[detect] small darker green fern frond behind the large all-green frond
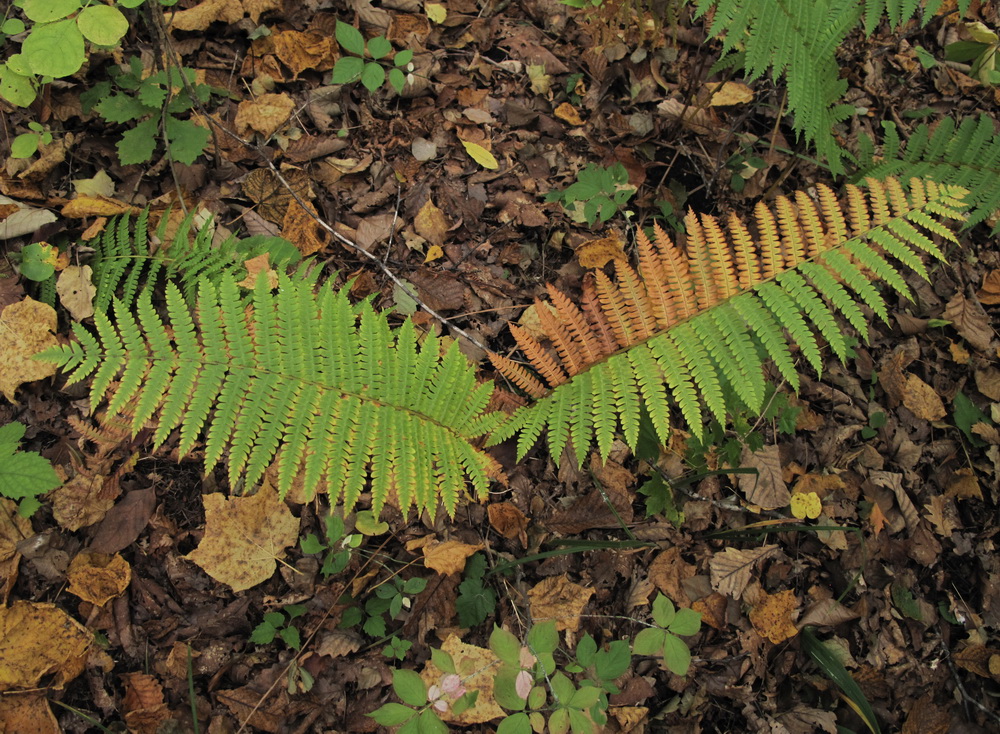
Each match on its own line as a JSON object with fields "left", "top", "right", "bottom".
{"left": 85, "top": 210, "right": 300, "bottom": 313}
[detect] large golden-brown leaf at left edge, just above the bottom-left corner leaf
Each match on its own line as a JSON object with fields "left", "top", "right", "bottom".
{"left": 0, "top": 600, "right": 94, "bottom": 698}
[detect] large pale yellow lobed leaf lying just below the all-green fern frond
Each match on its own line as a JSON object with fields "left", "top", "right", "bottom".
{"left": 185, "top": 484, "right": 299, "bottom": 591}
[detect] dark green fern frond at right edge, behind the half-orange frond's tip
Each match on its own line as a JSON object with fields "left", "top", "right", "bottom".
{"left": 856, "top": 115, "right": 1000, "bottom": 234}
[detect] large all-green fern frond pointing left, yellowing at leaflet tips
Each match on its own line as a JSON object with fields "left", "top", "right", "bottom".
{"left": 39, "top": 274, "right": 504, "bottom": 515}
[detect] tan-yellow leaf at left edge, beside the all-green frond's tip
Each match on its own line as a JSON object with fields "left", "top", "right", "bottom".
{"left": 0, "top": 298, "right": 58, "bottom": 403}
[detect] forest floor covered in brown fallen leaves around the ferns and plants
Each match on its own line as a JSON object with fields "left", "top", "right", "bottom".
{"left": 0, "top": 0, "right": 1000, "bottom": 734}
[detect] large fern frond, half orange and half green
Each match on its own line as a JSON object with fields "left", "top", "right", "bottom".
{"left": 489, "top": 180, "right": 964, "bottom": 461}
